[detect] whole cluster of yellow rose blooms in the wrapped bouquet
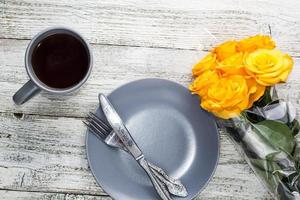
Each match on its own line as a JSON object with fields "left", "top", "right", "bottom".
{"left": 189, "top": 35, "right": 293, "bottom": 119}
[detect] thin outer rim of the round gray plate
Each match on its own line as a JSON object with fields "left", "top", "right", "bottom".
{"left": 85, "top": 78, "right": 221, "bottom": 200}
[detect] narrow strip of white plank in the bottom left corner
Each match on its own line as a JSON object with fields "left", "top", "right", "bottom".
{"left": 0, "top": 190, "right": 111, "bottom": 200}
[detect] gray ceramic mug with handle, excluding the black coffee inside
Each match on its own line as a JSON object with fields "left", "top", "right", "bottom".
{"left": 13, "top": 27, "right": 93, "bottom": 105}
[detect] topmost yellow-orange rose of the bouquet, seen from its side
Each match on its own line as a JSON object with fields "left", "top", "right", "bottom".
{"left": 237, "top": 35, "right": 276, "bottom": 52}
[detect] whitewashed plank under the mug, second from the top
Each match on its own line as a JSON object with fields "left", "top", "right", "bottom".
{"left": 0, "top": 39, "right": 300, "bottom": 117}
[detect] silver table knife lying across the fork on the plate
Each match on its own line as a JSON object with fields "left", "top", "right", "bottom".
{"left": 99, "top": 94, "right": 171, "bottom": 200}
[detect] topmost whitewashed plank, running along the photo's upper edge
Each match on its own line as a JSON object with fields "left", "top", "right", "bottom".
{"left": 0, "top": 0, "right": 300, "bottom": 56}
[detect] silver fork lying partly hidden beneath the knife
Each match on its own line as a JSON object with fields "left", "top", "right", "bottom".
{"left": 83, "top": 112, "right": 188, "bottom": 197}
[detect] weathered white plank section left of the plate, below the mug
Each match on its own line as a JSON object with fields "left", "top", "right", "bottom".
{"left": 0, "top": 115, "right": 104, "bottom": 195}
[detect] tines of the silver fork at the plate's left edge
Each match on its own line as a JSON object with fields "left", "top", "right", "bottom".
{"left": 83, "top": 112, "right": 112, "bottom": 139}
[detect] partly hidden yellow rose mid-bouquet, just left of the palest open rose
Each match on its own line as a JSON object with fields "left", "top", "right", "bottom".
{"left": 216, "top": 52, "right": 248, "bottom": 76}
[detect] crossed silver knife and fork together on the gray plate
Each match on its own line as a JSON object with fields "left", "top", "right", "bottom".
{"left": 84, "top": 94, "right": 188, "bottom": 199}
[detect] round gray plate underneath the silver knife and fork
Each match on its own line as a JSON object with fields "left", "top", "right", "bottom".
{"left": 86, "top": 79, "right": 219, "bottom": 200}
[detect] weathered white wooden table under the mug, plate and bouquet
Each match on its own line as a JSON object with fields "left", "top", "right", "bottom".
{"left": 0, "top": 0, "right": 300, "bottom": 200}
